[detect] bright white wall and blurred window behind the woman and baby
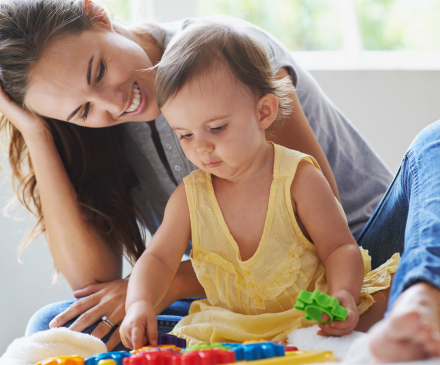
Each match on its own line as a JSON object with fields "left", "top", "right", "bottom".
{"left": 0, "top": 0, "right": 440, "bottom": 354}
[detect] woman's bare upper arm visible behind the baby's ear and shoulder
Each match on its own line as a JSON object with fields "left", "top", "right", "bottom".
{"left": 266, "top": 68, "right": 341, "bottom": 201}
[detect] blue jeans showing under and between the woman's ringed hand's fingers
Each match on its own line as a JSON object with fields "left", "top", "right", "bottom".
{"left": 26, "top": 298, "right": 198, "bottom": 351}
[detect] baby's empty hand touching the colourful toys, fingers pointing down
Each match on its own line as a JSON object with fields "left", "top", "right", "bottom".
{"left": 120, "top": 301, "right": 158, "bottom": 350}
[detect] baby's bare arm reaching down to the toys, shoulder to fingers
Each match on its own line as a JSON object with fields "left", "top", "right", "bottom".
{"left": 120, "top": 183, "right": 191, "bottom": 349}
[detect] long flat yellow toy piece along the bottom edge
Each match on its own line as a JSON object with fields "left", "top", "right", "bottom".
{"left": 235, "top": 351, "right": 336, "bottom": 365}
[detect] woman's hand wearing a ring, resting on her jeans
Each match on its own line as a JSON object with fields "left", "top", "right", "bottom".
{"left": 49, "top": 279, "right": 128, "bottom": 351}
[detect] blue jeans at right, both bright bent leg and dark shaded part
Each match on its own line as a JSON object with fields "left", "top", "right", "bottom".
{"left": 356, "top": 121, "right": 440, "bottom": 312}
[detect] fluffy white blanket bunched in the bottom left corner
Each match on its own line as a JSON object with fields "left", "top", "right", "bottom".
{"left": 0, "top": 328, "right": 107, "bottom": 365}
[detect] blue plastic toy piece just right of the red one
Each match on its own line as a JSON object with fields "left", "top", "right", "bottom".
{"left": 222, "top": 342, "right": 285, "bottom": 361}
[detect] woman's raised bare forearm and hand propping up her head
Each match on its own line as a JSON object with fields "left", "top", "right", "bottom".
{"left": 0, "top": 88, "right": 122, "bottom": 290}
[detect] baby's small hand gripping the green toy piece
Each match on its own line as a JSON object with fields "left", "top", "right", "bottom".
{"left": 317, "top": 291, "right": 359, "bottom": 336}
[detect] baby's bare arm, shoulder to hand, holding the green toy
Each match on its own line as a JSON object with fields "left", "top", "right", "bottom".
{"left": 291, "top": 161, "right": 364, "bottom": 335}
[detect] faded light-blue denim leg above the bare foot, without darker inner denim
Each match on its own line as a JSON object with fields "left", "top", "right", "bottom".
{"left": 388, "top": 121, "right": 440, "bottom": 310}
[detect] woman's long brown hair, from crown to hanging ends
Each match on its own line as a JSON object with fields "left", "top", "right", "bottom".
{"left": 0, "top": 0, "right": 155, "bottom": 262}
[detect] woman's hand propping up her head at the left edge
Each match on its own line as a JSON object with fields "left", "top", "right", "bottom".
{"left": 0, "top": 85, "right": 47, "bottom": 136}
